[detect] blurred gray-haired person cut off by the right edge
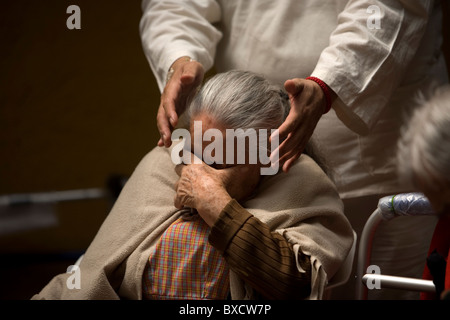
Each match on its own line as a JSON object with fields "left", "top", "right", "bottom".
{"left": 397, "top": 85, "right": 450, "bottom": 299}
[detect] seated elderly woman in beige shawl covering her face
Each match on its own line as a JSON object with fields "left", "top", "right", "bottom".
{"left": 33, "top": 71, "right": 353, "bottom": 299}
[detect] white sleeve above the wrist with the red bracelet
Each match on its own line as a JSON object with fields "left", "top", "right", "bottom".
{"left": 312, "top": 0, "right": 433, "bottom": 134}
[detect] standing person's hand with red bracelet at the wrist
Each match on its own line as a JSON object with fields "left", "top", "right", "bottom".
{"left": 271, "top": 78, "right": 336, "bottom": 172}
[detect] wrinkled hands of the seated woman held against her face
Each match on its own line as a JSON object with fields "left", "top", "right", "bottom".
{"left": 174, "top": 154, "right": 260, "bottom": 226}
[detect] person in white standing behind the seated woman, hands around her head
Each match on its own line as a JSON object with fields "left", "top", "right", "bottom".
{"left": 140, "top": 0, "right": 448, "bottom": 299}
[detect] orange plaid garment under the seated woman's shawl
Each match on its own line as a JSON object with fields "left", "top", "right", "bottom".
{"left": 143, "top": 214, "right": 229, "bottom": 300}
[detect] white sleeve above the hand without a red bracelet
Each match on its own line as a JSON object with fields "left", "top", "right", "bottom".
{"left": 139, "top": 0, "right": 222, "bottom": 92}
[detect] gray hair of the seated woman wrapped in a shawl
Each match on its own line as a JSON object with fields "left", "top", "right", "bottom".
{"left": 186, "top": 70, "right": 290, "bottom": 130}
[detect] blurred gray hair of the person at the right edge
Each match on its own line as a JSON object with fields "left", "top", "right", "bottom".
{"left": 397, "top": 85, "right": 450, "bottom": 187}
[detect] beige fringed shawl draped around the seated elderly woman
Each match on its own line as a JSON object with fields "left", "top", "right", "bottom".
{"left": 32, "top": 148, "right": 353, "bottom": 299}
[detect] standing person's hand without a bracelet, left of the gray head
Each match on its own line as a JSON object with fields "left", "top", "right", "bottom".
{"left": 156, "top": 57, "right": 205, "bottom": 147}
